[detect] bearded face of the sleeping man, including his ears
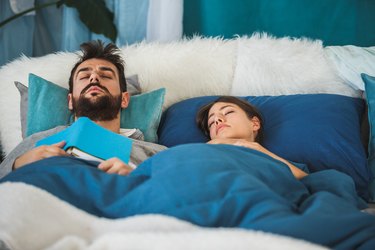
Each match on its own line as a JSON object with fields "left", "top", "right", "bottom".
{"left": 68, "top": 58, "right": 129, "bottom": 121}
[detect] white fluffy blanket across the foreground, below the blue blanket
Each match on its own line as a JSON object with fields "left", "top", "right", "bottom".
{"left": 0, "top": 183, "right": 325, "bottom": 250}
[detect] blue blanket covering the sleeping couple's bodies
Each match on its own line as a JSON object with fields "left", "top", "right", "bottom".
{"left": 1, "top": 144, "right": 375, "bottom": 249}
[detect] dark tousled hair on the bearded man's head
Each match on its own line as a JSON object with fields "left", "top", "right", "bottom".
{"left": 69, "top": 40, "right": 126, "bottom": 93}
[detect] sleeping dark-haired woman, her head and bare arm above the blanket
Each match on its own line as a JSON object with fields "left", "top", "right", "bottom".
{"left": 196, "top": 96, "right": 307, "bottom": 179}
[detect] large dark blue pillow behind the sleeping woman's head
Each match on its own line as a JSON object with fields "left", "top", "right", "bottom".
{"left": 158, "top": 94, "right": 371, "bottom": 200}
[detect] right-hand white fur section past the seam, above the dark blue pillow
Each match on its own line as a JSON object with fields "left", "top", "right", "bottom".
{"left": 231, "top": 34, "right": 360, "bottom": 96}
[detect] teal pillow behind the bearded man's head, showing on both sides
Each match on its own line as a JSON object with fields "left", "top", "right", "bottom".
{"left": 26, "top": 74, "right": 165, "bottom": 142}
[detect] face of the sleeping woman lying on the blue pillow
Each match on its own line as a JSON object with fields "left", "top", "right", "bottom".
{"left": 208, "top": 102, "right": 260, "bottom": 141}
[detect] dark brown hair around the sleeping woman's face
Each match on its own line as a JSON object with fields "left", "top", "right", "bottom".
{"left": 195, "top": 96, "right": 263, "bottom": 143}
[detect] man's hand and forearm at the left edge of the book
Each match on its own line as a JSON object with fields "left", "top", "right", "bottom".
{"left": 13, "top": 141, "right": 68, "bottom": 169}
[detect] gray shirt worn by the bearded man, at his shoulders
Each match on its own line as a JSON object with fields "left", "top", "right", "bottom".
{"left": 0, "top": 126, "right": 167, "bottom": 179}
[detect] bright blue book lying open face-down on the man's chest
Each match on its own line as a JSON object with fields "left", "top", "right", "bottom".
{"left": 36, "top": 117, "right": 132, "bottom": 163}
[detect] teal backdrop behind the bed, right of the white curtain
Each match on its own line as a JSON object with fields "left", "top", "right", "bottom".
{"left": 184, "top": 0, "right": 375, "bottom": 46}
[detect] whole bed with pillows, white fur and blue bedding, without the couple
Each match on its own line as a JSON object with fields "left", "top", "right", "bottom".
{"left": 0, "top": 34, "right": 375, "bottom": 249}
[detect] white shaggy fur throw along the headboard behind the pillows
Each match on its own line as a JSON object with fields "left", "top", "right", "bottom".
{"left": 0, "top": 35, "right": 356, "bottom": 154}
